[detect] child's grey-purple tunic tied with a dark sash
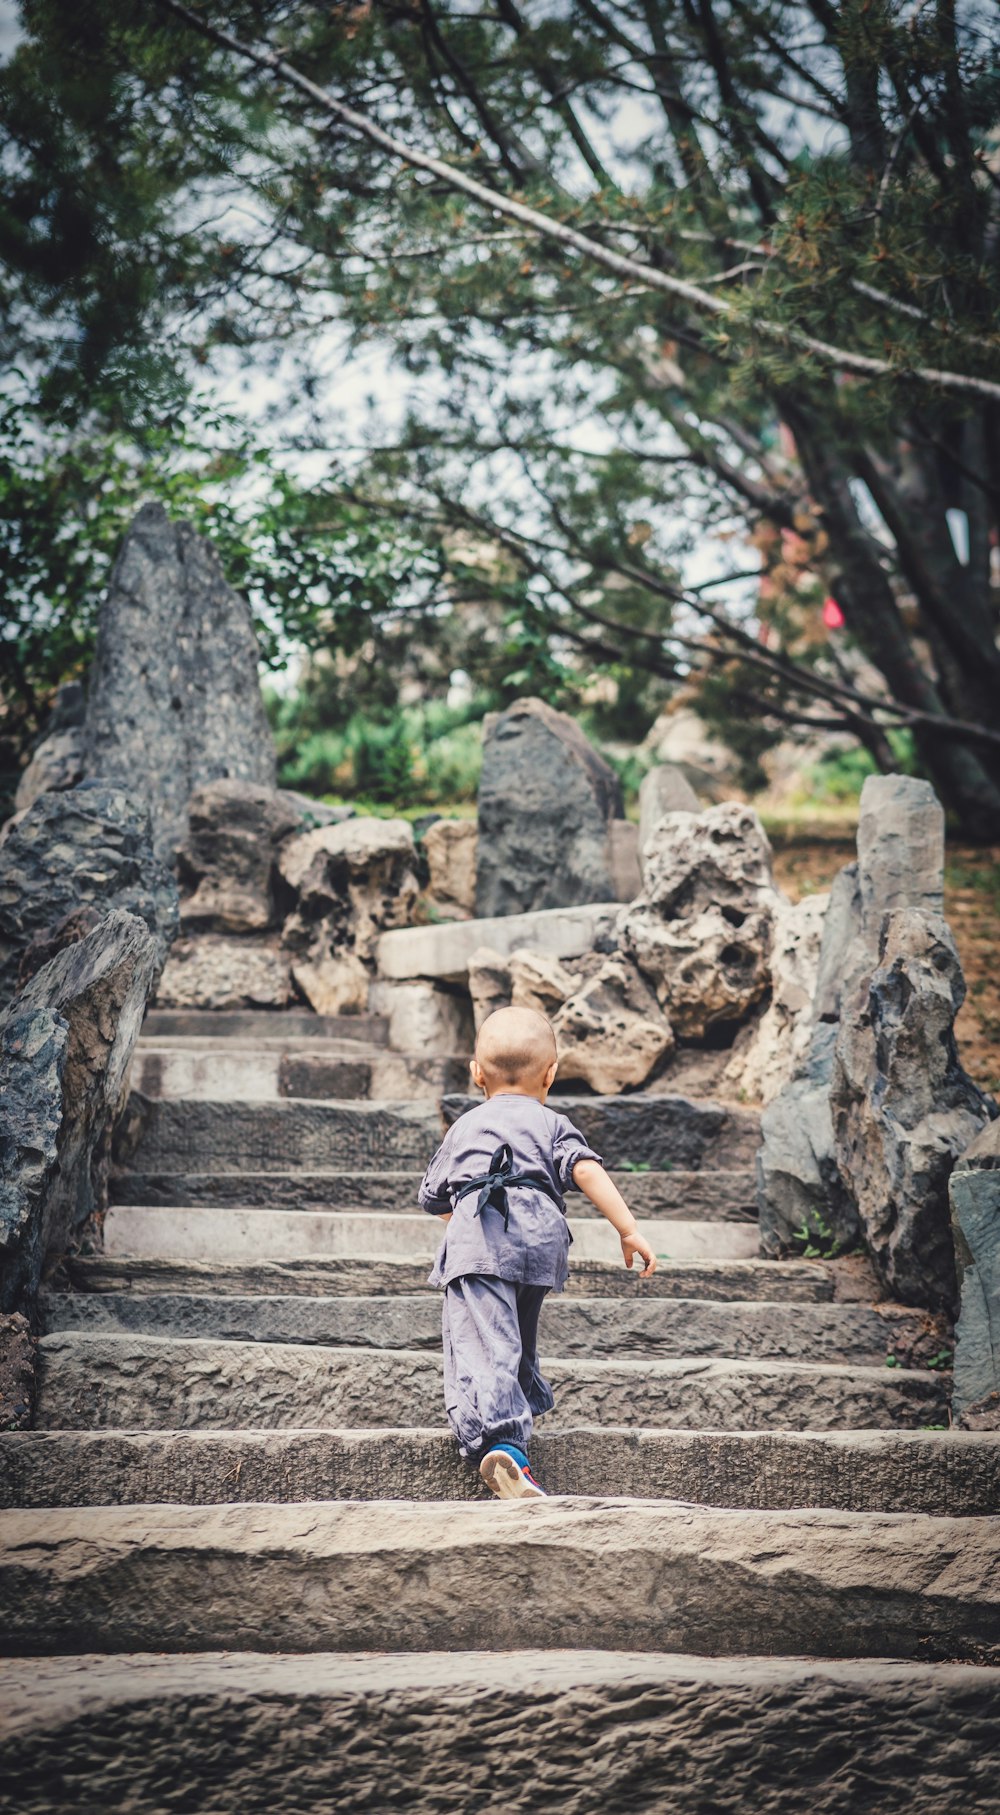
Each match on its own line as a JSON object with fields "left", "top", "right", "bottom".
{"left": 417, "top": 1091, "right": 601, "bottom": 1292}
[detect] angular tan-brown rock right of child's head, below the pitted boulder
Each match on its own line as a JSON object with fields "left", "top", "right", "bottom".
{"left": 551, "top": 953, "right": 673, "bottom": 1096}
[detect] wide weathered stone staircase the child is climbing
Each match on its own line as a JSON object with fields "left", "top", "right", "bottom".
{"left": 0, "top": 1015, "right": 1000, "bottom": 1815}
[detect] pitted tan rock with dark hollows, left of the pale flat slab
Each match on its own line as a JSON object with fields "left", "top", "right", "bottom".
{"left": 278, "top": 819, "right": 419, "bottom": 1015}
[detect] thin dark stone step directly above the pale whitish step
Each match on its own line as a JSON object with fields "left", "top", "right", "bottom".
{"left": 111, "top": 1167, "right": 757, "bottom": 1223}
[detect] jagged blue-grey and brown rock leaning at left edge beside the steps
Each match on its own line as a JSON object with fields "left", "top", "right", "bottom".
{"left": 0, "top": 909, "right": 158, "bottom": 1310}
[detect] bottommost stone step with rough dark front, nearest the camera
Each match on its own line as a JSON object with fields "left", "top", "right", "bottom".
{"left": 0, "top": 1655, "right": 1000, "bottom": 1815}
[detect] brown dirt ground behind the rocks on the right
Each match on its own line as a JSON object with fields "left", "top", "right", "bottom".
{"left": 773, "top": 837, "right": 1000, "bottom": 1093}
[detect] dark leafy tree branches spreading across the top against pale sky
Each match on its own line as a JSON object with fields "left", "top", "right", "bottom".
{"left": 0, "top": 0, "right": 1000, "bottom": 837}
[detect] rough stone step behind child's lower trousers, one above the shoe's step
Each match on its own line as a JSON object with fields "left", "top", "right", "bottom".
{"left": 36, "top": 1330, "right": 949, "bottom": 1430}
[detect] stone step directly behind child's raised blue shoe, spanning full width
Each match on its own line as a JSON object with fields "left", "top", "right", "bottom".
{"left": 0, "top": 1427, "right": 1000, "bottom": 1517}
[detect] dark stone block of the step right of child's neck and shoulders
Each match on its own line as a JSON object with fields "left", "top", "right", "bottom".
{"left": 441, "top": 1093, "right": 760, "bottom": 1171}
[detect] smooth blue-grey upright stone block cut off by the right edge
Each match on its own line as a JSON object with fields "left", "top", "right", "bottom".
{"left": 949, "top": 1120, "right": 1000, "bottom": 1430}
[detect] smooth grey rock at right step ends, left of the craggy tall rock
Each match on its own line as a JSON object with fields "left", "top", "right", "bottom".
{"left": 757, "top": 1022, "right": 862, "bottom": 1256}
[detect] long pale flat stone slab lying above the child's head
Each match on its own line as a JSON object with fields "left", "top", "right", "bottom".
{"left": 377, "top": 902, "right": 621, "bottom": 984}
